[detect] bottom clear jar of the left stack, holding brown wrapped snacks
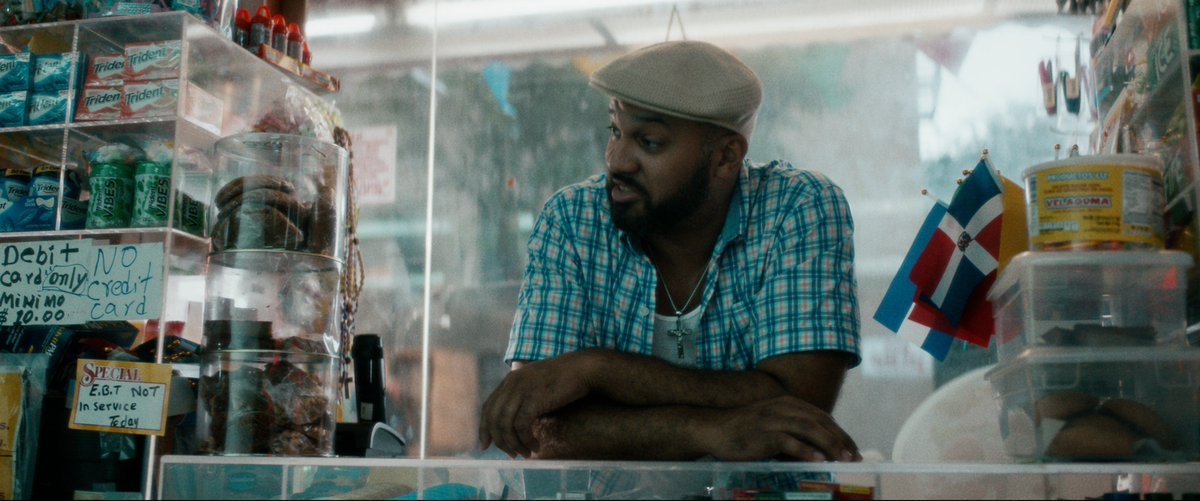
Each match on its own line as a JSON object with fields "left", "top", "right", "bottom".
{"left": 197, "top": 350, "right": 341, "bottom": 457}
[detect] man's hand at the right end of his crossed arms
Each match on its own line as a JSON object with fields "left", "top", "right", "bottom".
{"left": 697, "top": 397, "right": 863, "bottom": 461}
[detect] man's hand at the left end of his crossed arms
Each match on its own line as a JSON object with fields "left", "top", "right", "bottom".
{"left": 479, "top": 350, "right": 590, "bottom": 458}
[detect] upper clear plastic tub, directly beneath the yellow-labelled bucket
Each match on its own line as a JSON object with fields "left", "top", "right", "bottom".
{"left": 988, "top": 251, "right": 1192, "bottom": 362}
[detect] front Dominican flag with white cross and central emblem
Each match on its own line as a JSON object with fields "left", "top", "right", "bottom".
{"left": 908, "top": 158, "right": 1004, "bottom": 328}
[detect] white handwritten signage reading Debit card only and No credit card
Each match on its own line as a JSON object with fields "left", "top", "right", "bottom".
{"left": 0, "top": 240, "right": 163, "bottom": 325}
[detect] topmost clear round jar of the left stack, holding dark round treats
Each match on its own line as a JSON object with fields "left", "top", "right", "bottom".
{"left": 209, "top": 133, "right": 348, "bottom": 259}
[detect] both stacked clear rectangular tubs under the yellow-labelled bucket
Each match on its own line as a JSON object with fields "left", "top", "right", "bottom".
{"left": 988, "top": 251, "right": 1200, "bottom": 461}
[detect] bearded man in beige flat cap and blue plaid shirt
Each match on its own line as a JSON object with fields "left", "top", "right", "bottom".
{"left": 480, "top": 41, "right": 862, "bottom": 461}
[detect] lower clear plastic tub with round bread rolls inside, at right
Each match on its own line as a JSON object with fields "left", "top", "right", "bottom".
{"left": 986, "top": 348, "right": 1200, "bottom": 463}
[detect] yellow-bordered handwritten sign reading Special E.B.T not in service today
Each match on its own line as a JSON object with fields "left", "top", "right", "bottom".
{"left": 68, "top": 360, "right": 170, "bottom": 435}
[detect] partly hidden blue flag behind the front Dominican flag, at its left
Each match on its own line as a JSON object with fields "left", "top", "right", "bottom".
{"left": 874, "top": 201, "right": 954, "bottom": 361}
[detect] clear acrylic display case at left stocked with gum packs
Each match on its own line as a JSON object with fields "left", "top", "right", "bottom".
{"left": 0, "top": 12, "right": 344, "bottom": 497}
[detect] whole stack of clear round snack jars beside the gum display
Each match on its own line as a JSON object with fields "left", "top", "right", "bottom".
{"left": 197, "top": 133, "right": 348, "bottom": 455}
